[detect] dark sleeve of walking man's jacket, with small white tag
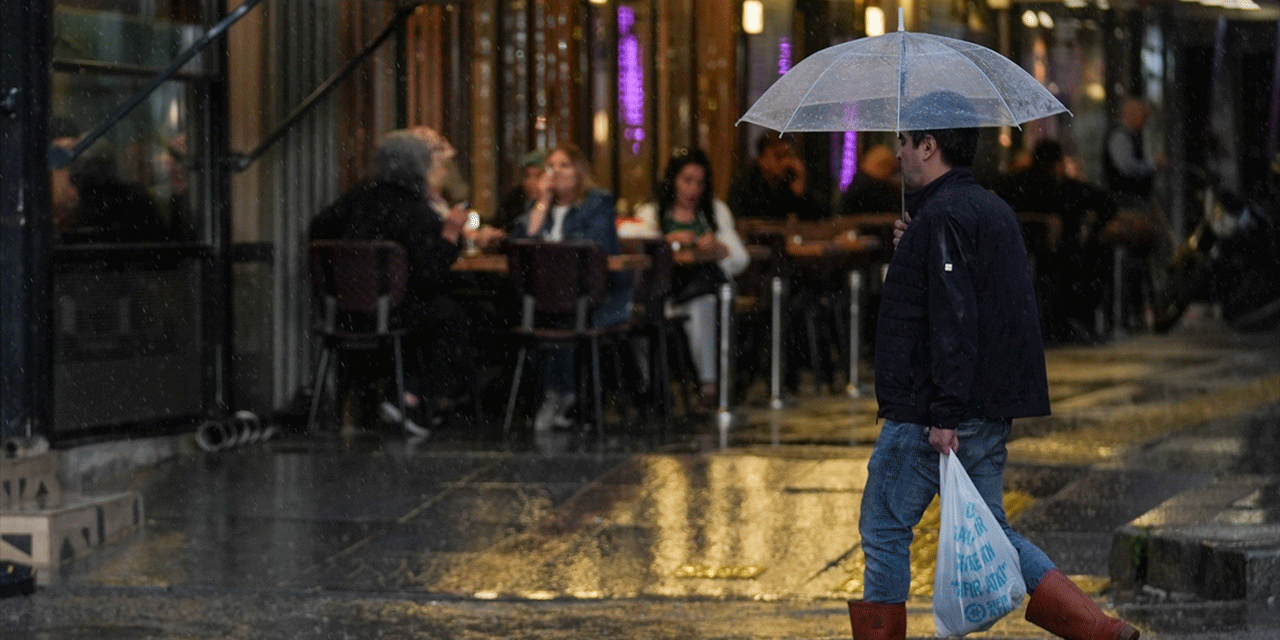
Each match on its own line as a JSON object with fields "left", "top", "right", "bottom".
{"left": 924, "top": 211, "right": 980, "bottom": 429}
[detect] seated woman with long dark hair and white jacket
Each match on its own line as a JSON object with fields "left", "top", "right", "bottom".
{"left": 636, "top": 150, "right": 750, "bottom": 412}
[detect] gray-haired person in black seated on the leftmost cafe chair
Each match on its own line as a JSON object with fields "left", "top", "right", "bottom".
{"left": 310, "top": 127, "right": 476, "bottom": 436}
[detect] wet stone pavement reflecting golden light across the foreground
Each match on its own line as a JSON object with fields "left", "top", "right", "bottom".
{"left": 0, "top": 309, "right": 1280, "bottom": 640}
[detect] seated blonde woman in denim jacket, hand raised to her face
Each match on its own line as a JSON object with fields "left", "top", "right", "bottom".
{"left": 511, "top": 143, "right": 631, "bottom": 431}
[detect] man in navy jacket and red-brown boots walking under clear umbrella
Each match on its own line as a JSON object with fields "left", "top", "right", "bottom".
{"left": 849, "top": 92, "right": 1138, "bottom": 640}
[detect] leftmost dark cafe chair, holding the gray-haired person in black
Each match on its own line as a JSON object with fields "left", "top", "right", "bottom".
{"left": 307, "top": 241, "right": 408, "bottom": 431}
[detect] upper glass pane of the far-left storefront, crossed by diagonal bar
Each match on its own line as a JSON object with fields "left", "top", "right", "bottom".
{"left": 50, "top": 0, "right": 209, "bottom": 244}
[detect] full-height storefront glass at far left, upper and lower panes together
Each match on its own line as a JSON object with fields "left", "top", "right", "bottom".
{"left": 49, "top": 0, "right": 212, "bottom": 434}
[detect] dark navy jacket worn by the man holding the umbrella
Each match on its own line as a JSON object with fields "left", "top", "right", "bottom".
{"left": 876, "top": 168, "right": 1050, "bottom": 429}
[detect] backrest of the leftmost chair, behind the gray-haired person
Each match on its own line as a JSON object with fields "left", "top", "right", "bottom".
{"left": 310, "top": 239, "right": 408, "bottom": 333}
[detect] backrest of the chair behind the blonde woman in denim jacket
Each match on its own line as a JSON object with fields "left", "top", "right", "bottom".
{"left": 507, "top": 239, "right": 608, "bottom": 328}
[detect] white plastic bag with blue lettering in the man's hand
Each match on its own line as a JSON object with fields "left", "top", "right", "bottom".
{"left": 933, "top": 453, "right": 1027, "bottom": 637}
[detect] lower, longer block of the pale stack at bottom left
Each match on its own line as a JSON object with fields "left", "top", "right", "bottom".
{"left": 0, "top": 493, "right": 143, "bottom": 585}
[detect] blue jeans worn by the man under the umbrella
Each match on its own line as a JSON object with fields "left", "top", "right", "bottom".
{"left": 858, "top": 419, "right": 1053, "bottom": 604}
